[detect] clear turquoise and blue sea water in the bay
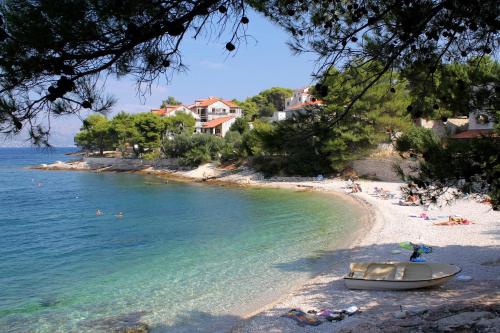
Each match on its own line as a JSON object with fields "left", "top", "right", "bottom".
{"left": 0, "top": 148, "right": 361, "bottom": 332}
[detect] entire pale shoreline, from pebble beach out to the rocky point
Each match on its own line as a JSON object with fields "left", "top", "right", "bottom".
{"left": 35, "top": 160, "right": 500, "bottom": 332}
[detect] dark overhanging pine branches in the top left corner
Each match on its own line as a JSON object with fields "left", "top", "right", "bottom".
{"left": 0, "top": 0, "right": 248, "bottom": 144}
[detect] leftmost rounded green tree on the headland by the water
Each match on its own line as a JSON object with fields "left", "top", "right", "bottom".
{"left": 75, "top": 114, "right": 111, "bottom": 156}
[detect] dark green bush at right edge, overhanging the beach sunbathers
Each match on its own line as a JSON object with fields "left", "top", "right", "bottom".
{"left": 397, "top": 135, "right": 500, "bottom": 210}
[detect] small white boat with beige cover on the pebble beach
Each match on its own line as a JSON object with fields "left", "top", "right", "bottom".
{"left": 344, "top": 262, "right": 462, "bottom": 290}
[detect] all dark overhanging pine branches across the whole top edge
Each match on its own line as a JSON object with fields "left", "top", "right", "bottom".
{"left": 0, "top": 0, "right": 500, "bottom": 144}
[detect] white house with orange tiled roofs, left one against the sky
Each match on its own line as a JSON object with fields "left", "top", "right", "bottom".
{"left": 189, "top": 97, "right": 243, "bottom": 123}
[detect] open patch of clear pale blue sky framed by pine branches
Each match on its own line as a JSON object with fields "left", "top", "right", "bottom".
{"left": 0, "top": 12, "right": 315, "bottom": 146}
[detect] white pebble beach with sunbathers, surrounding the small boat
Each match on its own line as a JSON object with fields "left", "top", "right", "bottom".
{"left": 228, "top": 180, "right": 500, "bottom": 332}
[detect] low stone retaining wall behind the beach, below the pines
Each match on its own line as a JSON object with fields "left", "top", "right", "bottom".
{"left": 352, "top": 157, "right": 418, "bottom": 182}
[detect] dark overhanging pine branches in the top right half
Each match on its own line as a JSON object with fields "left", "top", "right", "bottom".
{"left": 252, "top": 0, "right": 500, "bottom": 121}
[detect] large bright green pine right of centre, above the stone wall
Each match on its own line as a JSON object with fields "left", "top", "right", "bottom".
{"left": 314, "top": 63, "right": 412, "bottom": 171}
